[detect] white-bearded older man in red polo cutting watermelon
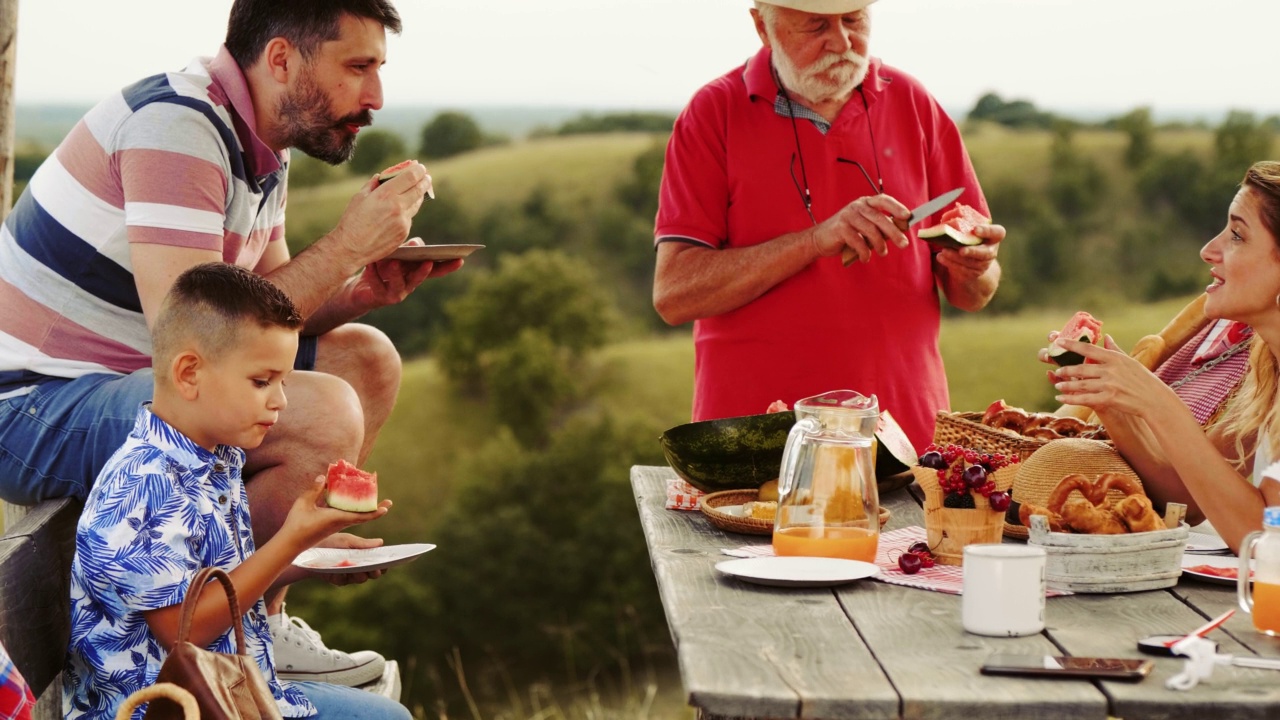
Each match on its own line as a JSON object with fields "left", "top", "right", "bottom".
{"left": 654, "top": 0, "right": 1005, "bottom": 447}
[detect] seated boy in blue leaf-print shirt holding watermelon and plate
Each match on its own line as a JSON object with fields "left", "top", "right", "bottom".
{"left": 63, "top": 263, "right": 408, "bottom": 720}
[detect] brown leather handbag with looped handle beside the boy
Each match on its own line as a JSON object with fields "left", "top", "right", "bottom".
{"left": 143, "top": 568, "right": 283, "bottom": 720}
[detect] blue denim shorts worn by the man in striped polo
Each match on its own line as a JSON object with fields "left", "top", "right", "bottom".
{"left": 0, "top": 337, "right": 316, "bottom": 505}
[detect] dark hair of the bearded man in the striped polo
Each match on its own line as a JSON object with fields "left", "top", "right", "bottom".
{"left": 225, "top": 0, "right": 401, "bottom": 69}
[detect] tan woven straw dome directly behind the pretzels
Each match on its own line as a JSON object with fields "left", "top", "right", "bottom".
{"left": 1005, "top": 438, "right": 1142, "bottom": 539}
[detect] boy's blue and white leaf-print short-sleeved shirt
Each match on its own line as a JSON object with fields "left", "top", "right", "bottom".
{"left": 63, "top": 405, "right": 316, "bottom": 720}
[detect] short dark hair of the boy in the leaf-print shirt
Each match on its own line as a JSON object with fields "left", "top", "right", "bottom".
{"left": 151, "top": 263, "right": 302, "bottom": 368}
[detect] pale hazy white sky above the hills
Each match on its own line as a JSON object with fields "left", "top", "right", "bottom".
{"left": 15, "top": 0, "right": 1280, "bottom": 114}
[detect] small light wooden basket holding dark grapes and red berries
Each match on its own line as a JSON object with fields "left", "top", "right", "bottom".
{"left": 911, "top": 464, "right": 1018, "bottom": 565}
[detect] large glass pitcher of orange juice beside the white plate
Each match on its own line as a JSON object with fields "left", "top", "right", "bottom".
{"left": 773, "top": 389, "right": 879, "bottom": 562}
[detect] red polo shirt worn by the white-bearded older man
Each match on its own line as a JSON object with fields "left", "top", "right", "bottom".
{"left": 655, "top": 49, "right": 989, "bottom": 448}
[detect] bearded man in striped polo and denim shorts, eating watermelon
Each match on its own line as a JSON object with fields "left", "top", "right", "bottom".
{"left": 0, "top": 0, "right": 461, "bottom": 684}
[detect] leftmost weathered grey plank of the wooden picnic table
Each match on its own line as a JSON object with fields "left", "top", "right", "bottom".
{"left": 632, "top": 468, "right": 899, "bottom": 719}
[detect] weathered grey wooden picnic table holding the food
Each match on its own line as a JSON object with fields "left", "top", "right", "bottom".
{"left": 631, "top": 465, "right": 1280, "bottom": 720}
